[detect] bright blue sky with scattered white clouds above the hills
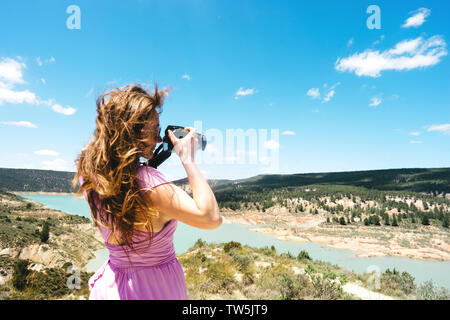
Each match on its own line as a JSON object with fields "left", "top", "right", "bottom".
{"left": 0, "top": 0, "right": 450, "bottom": 179}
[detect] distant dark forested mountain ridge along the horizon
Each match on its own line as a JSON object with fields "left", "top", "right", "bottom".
{"left": 0, "top": 168, "right": 450, "bottom": 196}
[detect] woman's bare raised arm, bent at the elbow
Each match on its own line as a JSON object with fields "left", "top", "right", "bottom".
{"left": 148, "top": 128, "right": 222, "bottom": 229}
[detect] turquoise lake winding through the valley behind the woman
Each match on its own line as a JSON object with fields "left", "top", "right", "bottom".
{"left": 21, "top": 195, "right": 450, "bottom": 289}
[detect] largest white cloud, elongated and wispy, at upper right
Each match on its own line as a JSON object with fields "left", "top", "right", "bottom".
{"left": 335, "top": 36, "right": 447, "bottom": 77}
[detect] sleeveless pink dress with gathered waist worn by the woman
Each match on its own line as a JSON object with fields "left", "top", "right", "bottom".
{"left": 80, "top": 166, "right": 187, "bottom": 300}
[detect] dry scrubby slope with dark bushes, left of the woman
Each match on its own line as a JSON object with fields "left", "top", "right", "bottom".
{"left": 0, "top": 191, "right": 104, "bottom": 299}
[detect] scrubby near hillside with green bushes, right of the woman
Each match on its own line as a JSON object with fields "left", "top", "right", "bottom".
{"left": 178, "top": 239, "right": 450, "bottom": 300}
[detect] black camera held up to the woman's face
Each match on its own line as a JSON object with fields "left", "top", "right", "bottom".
{"left": 144, "top": 125, "right": 206, "bottom": 169}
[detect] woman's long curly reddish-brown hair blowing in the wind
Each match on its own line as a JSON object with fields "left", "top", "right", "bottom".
{"left": 72, "top": 84, "right": 168, "bottom": 256}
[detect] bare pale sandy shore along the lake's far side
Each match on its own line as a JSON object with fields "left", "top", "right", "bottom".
{"left": 224, "top": 216, "right": 450, "bottom": 261}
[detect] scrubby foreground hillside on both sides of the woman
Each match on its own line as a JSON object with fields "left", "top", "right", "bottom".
{"left": 0, "top": 191, "right": 450, "bottom": 300}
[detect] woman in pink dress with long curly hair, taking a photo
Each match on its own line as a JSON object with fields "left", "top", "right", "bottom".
{"left": 73, "top": 85, "right": 222, "bottom": 299}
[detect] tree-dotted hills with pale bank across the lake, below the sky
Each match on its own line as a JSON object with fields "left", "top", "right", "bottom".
{"left": 0, "top": 168, "right": 450, "bottom": 261}
